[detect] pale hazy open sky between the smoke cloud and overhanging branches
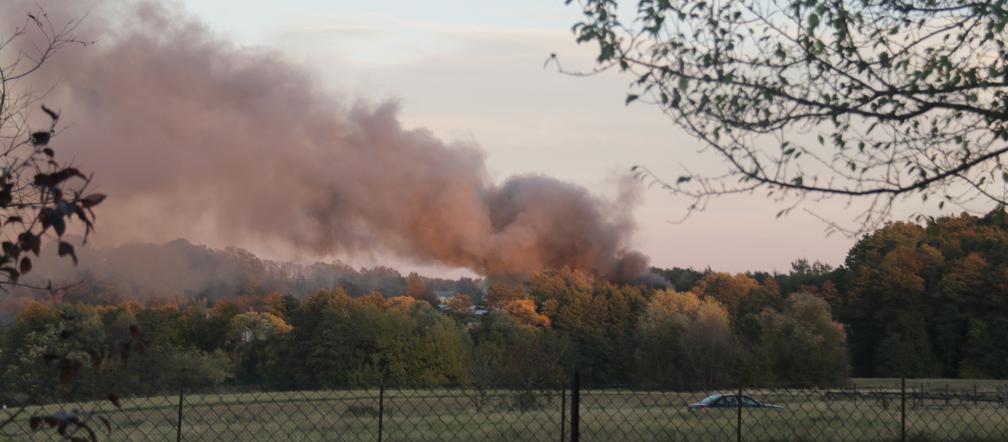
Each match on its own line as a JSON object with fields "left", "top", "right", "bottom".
{"left": 169, "top": 0, "right": 853, "bottom": 271}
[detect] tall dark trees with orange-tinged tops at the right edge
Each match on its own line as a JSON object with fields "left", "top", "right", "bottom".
{"left": 835, "top": 209, "right": 1008, "bottom": 376}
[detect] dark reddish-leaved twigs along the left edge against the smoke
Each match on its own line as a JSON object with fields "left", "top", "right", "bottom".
{"left": 0, "top": 9, "right": 105, "bottom": 292}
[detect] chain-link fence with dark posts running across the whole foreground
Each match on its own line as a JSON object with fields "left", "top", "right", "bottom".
{"left": 0, "top": 379, "right": 1008, "bottom": 442}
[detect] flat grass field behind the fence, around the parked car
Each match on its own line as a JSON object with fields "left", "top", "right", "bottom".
{"left": 0, "top": 379, "right": 1008, "bottom": 442}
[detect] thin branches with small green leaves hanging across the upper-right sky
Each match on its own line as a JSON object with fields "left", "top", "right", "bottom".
{"left": 554, "top": 0, "right": 1008, "bottom": 232}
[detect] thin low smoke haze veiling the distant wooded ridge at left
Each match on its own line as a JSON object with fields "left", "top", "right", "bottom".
{"left": 0, "top": 239, "right": 483, "bottom": 322}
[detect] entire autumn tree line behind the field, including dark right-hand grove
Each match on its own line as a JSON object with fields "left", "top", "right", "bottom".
{"left": 0, "top": 210, "right": 1008, "bottom": 397}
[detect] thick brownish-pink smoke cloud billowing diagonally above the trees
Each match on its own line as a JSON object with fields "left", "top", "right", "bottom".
{"left": 0, "top": 1, "right": 646, "bottom": 279}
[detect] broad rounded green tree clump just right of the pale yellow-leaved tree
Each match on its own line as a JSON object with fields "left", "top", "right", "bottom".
{"left": 265, "top": 291, "right": 466, "bottom": 388}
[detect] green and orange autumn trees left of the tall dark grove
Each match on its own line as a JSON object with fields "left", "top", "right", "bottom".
{"left": 0, "top": 269, "right": 847, "bottom": 392}
